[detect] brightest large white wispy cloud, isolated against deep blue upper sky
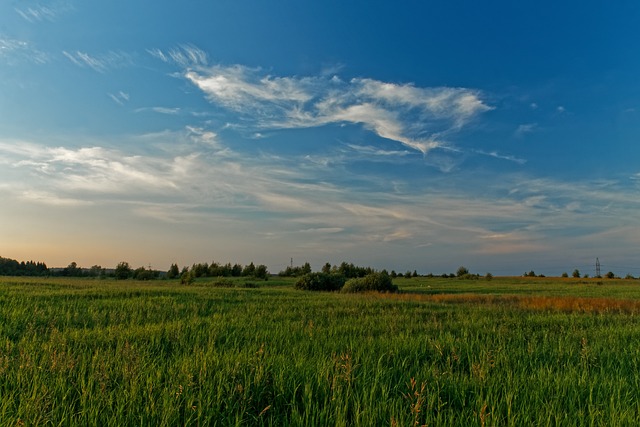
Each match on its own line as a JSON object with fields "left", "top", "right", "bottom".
{"left": 165, "top": 58, "right": 492, "bottom": 154}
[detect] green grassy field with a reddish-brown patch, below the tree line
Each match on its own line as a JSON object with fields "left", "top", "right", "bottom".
{"left": 0, "top": 278, "right": 640, "bottom": 426}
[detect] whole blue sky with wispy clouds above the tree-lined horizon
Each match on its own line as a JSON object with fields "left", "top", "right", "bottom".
{"left": 0, "top": 0, "right": 640, "bottom": 276}
